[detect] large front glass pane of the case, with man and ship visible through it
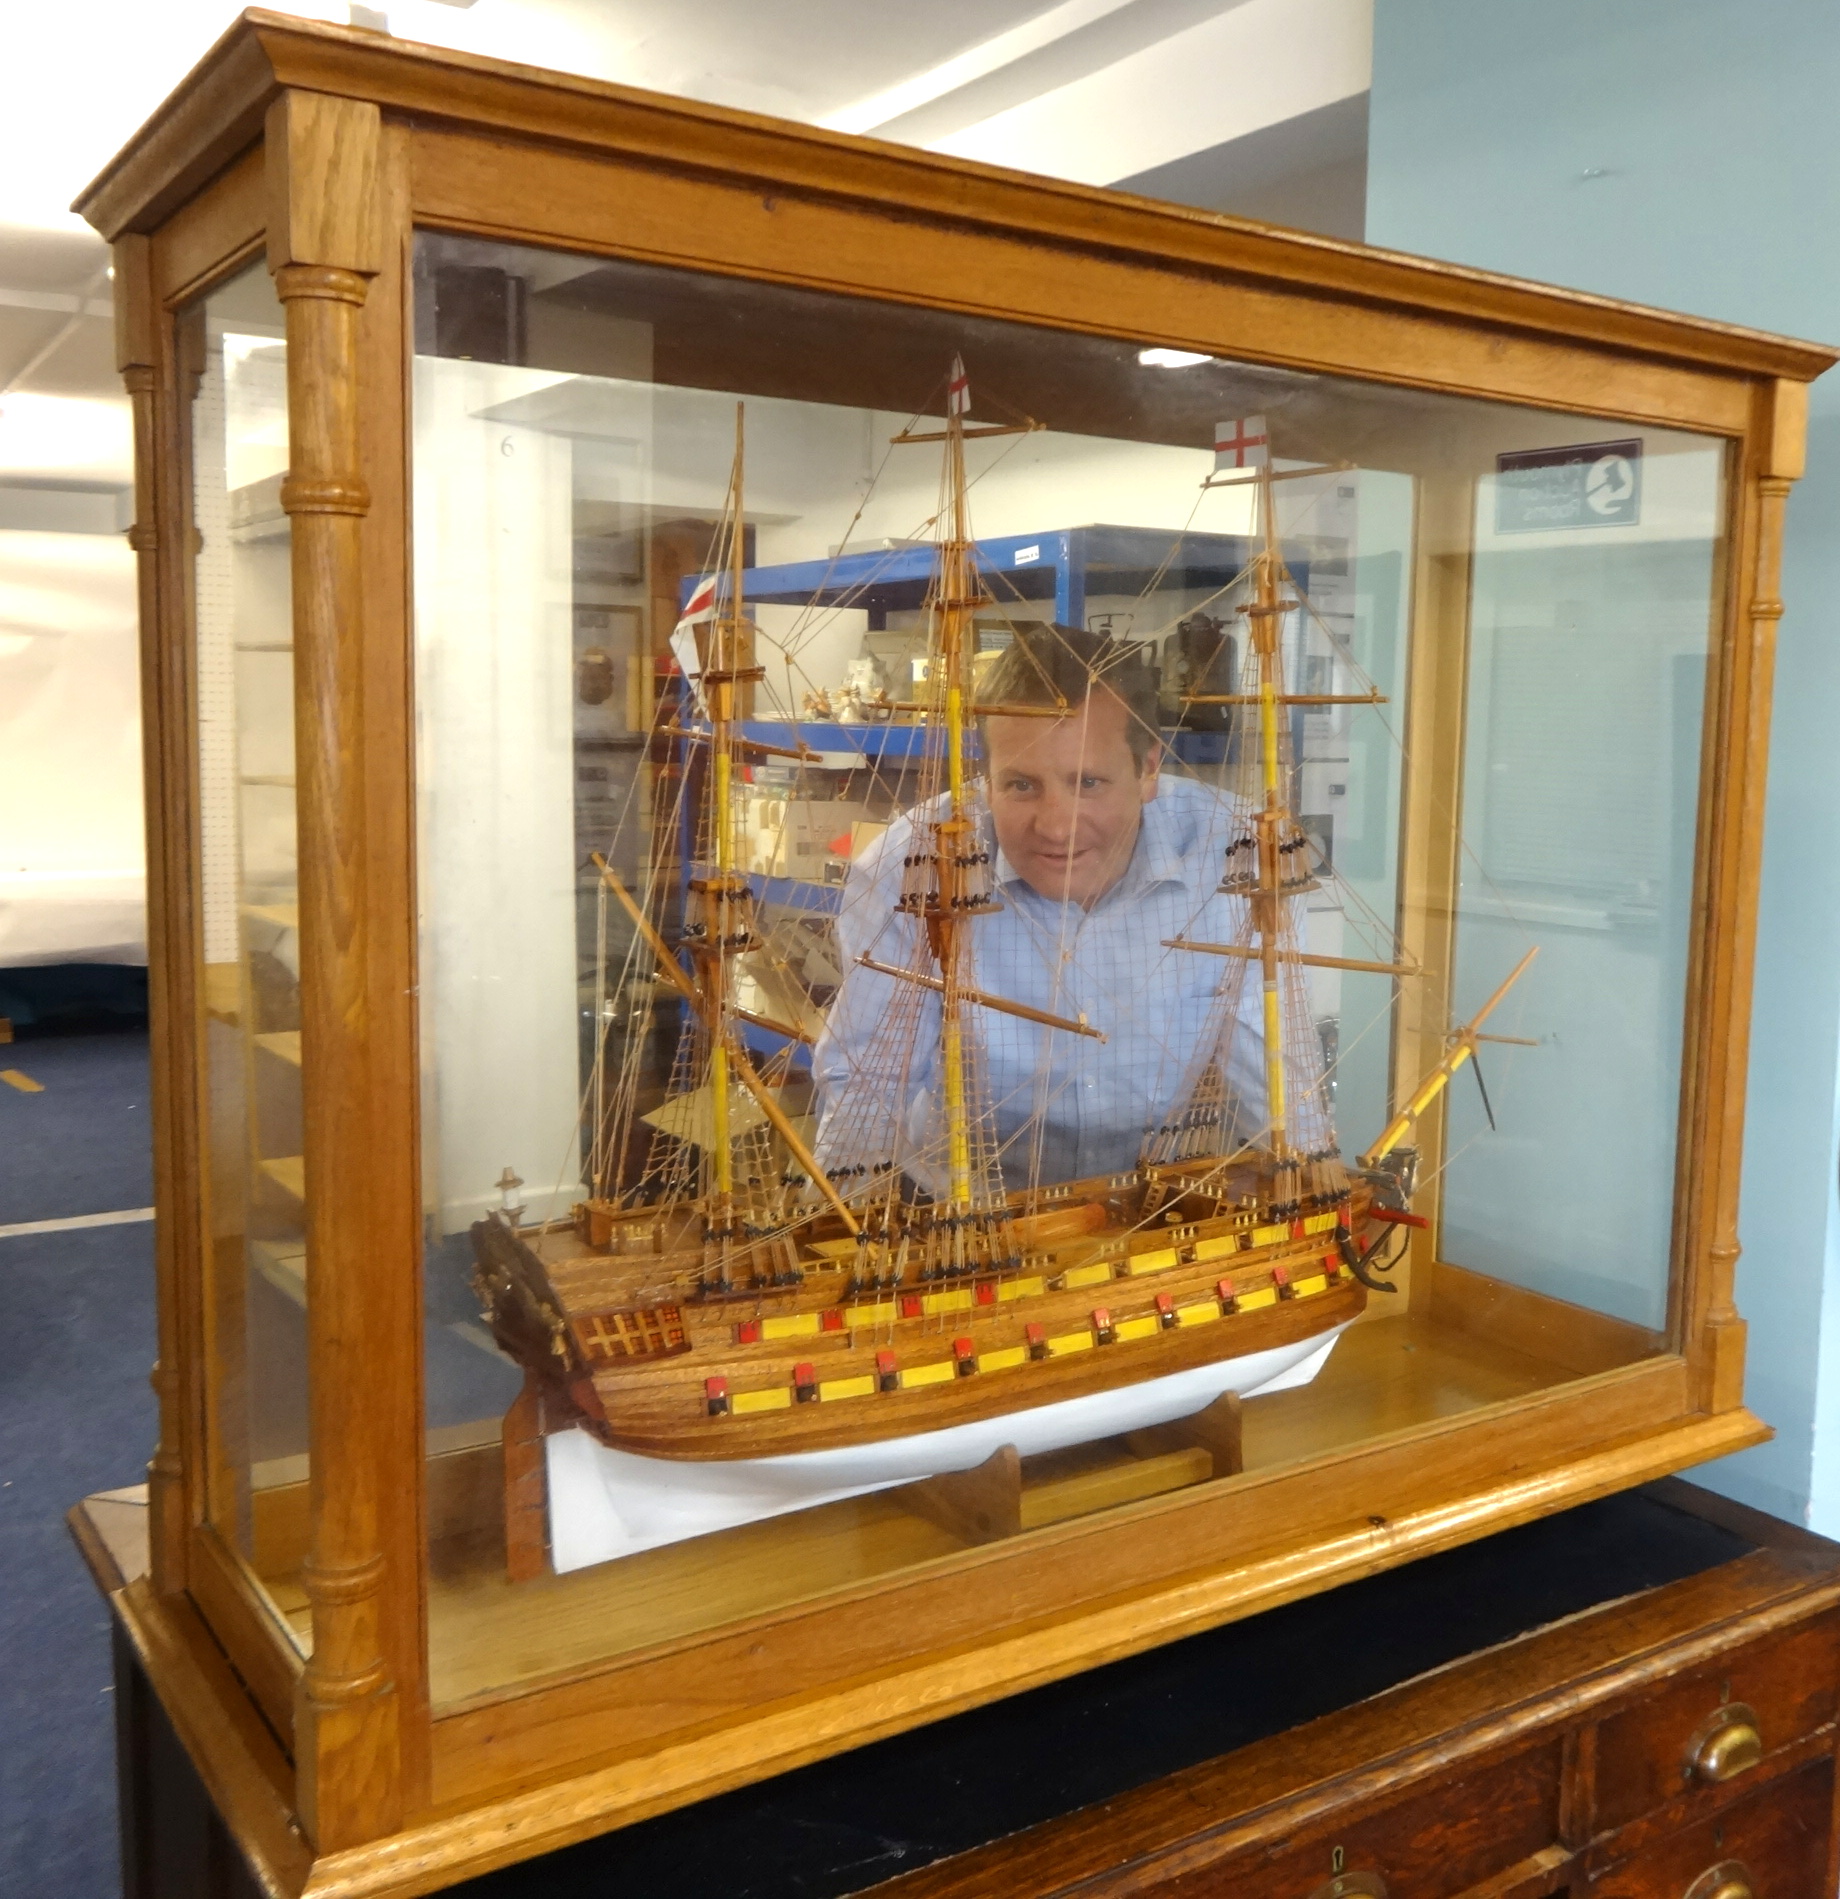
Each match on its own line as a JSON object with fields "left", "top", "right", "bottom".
{"left": 414, "top": 237, "right": 1718, "bottom": 1702}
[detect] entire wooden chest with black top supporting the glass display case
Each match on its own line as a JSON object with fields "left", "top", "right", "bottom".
{"left": 91, "top": 1483, "right": 1840, "bottom": 1899}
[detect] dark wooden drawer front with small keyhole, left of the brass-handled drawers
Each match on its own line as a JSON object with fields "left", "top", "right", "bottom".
{"left": 1124, "top": 1741, "right": 1565, "bottom": 1899}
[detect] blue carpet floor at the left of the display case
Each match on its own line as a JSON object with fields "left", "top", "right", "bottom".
{"left": 0, "top": 1033, "right": 154, "bottom": 1899}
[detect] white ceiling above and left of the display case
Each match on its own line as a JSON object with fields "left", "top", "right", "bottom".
{"left": 0, "top": 0, "right": 1373, "bottom": 489}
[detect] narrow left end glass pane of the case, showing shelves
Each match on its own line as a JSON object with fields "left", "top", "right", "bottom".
{"left": 180, "top": 266, "right": 310, "bottom": 1646}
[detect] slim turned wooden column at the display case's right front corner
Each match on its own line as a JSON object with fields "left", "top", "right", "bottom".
{"left": 1682, "top": 382, "right": 1808, "bottom": 1411}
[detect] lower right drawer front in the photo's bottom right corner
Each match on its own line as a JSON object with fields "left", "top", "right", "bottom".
{"left": 1584, "top": 1757, "right": 1834, "bottom": 1899}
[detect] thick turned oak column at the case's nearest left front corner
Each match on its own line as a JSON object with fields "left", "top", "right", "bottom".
{"left": 266, "top": 93, "right": 403, "bottom": 1852}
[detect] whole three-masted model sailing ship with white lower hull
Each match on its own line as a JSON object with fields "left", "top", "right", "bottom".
{"left": 473, "top": 363, "right": 1525, "bottom": 1553}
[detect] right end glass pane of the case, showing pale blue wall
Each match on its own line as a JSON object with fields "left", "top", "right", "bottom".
{"left": 1443, "top": 429, "right": 1724, "bottom": 1331}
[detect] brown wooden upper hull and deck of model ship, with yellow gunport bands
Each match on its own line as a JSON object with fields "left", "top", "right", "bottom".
{"left": 479, "top": 1175, "right": 1369, "bottom": 1460}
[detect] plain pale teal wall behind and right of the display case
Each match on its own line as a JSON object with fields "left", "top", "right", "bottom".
{"left": 1367, "top": 0, "right": 1840, "bottom": 1511}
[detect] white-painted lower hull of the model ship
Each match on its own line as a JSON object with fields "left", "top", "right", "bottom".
{"left": 547, "top": 1322, "right": 1346, "bottom": 1572}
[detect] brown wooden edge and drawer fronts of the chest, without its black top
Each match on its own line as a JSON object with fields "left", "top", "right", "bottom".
{"left": 877, "top": 1485, "right": 1840, "bottom": 1899}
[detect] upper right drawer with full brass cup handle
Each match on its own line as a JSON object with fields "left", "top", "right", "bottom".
{"left": 1591, "top": 1616, "right": 1840, "bottom": 1836}
